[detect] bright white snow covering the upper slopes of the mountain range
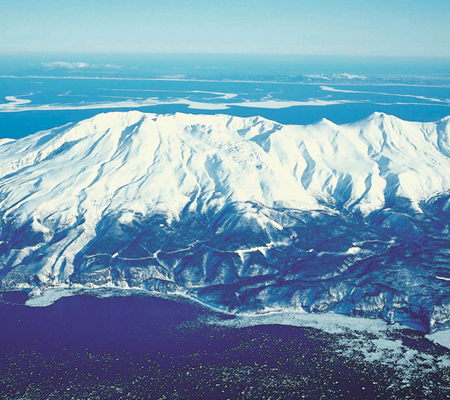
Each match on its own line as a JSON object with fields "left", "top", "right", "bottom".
{"left": 0, "top": 111, "right": 450, "bottom": 290}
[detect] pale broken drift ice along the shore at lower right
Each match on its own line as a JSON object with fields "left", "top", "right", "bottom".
{"left": 212, "top": 310, "right": 450, "bottom": 387}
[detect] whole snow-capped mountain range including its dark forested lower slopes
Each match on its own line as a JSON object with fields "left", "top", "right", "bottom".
{"left": 0, "top": 112, "right": 450, "bottom": 330}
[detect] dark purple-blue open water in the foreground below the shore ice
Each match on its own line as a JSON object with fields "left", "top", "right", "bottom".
{"left": 0, "top": 293, "right": 441, "bottom": 399}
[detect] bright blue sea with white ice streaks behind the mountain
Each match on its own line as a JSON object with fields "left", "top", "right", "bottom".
{"left": 0, "top": 55, "right": 450, "bottom": 138}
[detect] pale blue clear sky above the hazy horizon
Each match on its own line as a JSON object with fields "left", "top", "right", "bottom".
{"left": 0, "top": 0, "right": 450, "bottom": 57}
